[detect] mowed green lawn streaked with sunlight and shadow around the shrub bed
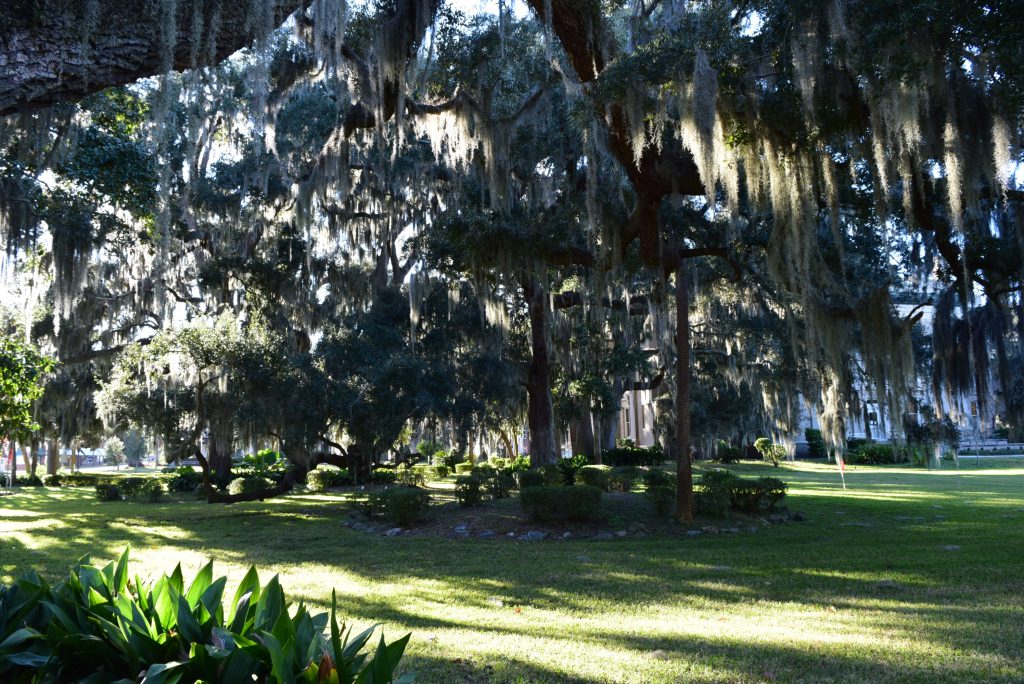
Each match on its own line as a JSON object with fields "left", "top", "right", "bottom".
{"left": 0, "top": 459, "right": 1024, "bottom": 682}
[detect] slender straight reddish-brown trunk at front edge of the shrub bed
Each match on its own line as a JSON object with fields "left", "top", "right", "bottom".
{"left": 676, "top": 260, "right": 693, "bottom": 522}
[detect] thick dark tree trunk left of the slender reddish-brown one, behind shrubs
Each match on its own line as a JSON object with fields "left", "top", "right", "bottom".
{"left": 523, "top": 281, "right": 558, "bottom": 466}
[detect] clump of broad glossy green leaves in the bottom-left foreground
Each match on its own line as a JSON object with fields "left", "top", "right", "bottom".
{"left": 0, "top": 549, "right": 413, "bottom": 684}
